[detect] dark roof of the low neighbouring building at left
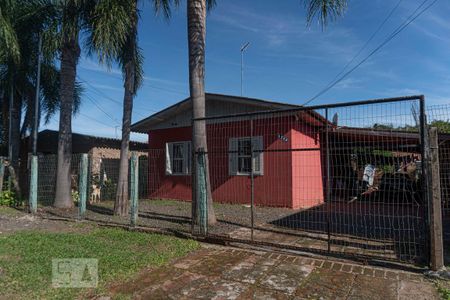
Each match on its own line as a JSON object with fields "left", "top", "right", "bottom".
{"left": 24, "top": 129, "right": 148, "bottom": 153}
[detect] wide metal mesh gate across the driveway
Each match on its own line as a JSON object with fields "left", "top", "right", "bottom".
{"left": 193, "top": 96, "right": 428, "bottom": 263}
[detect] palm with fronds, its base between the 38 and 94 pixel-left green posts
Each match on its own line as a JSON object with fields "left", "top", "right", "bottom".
{"left": 54, "top": 0, "right": 128, "bottom": 208}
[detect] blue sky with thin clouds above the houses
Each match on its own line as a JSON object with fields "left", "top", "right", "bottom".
{"left": 41, "top": 0, "right": 450, "bottom": 141}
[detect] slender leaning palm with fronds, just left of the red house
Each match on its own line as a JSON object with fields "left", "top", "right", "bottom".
{"left": 89, "top": 0, "right": 178, "bottom": 216}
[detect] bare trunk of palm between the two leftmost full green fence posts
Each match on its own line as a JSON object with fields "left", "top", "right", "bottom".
{"left": 54, "top": 34, "right": 80, "bottom": 208}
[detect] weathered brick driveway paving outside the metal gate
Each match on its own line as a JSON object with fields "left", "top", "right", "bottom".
{"left": 110, "top": 248, "right": 439, "bottom": 299}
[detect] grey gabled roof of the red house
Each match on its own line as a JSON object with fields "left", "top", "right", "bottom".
{"left": 131, "top": 93, "right": 323, "bottom": 133}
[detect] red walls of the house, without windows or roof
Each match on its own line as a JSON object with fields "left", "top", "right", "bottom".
{"left": 149, "top": 117, "right": 323, "bottom": 208}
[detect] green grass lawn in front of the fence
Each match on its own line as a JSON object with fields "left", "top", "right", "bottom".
{"left": 0, "top": 229, "right": 199, "bottom": 299}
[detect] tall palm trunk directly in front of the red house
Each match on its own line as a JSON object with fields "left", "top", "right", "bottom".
{"left": 187, "top": 0, "right": 217, "bottom": 225}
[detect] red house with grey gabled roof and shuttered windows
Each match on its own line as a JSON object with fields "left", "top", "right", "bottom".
{"left": 131, "top": 94, "right": 324, "bottom": 209}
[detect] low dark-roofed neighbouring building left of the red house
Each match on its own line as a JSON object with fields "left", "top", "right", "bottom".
{"left": 20, "top": 130, "right": 148, "bottom": 203}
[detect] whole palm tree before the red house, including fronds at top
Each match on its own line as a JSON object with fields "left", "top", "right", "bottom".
{"left": 187, "top": 0, "right": 347, "bottom": 224}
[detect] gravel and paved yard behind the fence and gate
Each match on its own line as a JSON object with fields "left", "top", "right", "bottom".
{"left": 39, "top": 200, "right": 425, "bottom": 264}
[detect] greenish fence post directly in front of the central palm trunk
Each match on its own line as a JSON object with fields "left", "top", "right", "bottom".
{"left": 196, "top": 148, "right": 208, "bottom": 235}
